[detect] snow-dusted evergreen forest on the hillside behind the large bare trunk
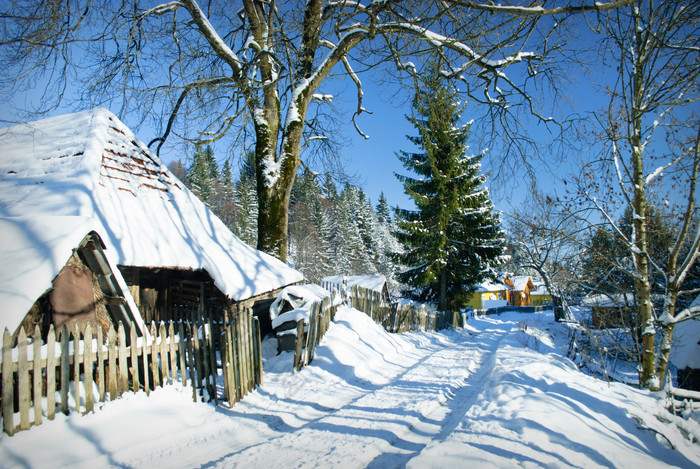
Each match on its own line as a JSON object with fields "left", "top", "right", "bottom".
{"left": 170, "top": 146, "right": 400, "bottom": 293}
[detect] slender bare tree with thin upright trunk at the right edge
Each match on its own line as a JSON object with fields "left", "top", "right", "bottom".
{"left": 568, "top": 0, "right": 700, "bottom": 389}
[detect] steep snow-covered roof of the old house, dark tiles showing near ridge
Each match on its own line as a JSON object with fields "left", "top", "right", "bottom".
{"left": 0, "top": 108, "right": 303, "bottom": 330}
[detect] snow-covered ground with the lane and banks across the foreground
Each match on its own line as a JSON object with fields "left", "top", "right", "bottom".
{"left": 0, "top": 307, "right": 700, "bottom": 469}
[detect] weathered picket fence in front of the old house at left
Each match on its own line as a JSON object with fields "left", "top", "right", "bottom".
{"left": 0, "top": 310, "right": 262, "bottom": 435}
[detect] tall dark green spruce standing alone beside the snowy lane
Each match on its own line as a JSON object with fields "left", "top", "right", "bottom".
{"left": 396, "top": 65, "right": 503, "bottom": 310}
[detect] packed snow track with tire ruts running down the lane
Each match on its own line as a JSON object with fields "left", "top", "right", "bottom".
{"left": 203, "top": 312, "right": 514, "bottom": 467}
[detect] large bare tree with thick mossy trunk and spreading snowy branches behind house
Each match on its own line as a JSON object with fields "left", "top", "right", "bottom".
{"left": 0, "top": 0, "right": 631, "bottom": 260}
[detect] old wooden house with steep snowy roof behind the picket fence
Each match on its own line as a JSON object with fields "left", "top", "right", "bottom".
{"left": 0, "top": 108, "right": 303, "bottom": 332}
